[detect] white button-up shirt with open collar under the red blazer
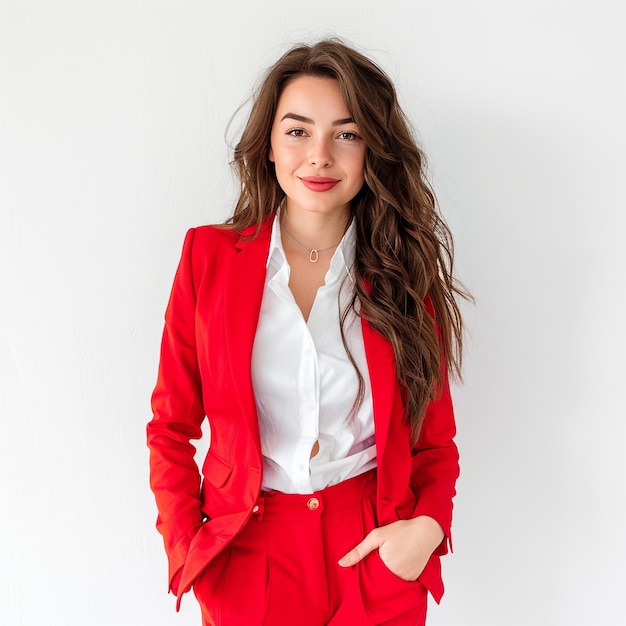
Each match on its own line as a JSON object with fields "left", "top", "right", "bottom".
{"left": 252, "top": 217, "right": 376, "bottom": 493}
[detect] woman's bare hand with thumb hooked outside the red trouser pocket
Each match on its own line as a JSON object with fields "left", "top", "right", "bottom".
{"left": 339, "top": 515, "right": 444, "bottom": 580}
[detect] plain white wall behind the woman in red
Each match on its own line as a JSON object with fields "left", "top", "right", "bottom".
{"left": 0, "top": 0, "right": 626, "bottom": 626}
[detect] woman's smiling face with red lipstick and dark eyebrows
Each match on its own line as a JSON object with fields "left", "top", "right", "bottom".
{"left": 269, "top": 76, "right": 365, "bottom": 222}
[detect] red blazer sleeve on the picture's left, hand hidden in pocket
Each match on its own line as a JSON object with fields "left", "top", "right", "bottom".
{"left": 147, "top": 229, "right": 205, "bottom": 593}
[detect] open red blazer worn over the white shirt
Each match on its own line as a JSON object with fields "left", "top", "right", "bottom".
{"left": 147, "top": 219, "right": 459, "bottom": 603}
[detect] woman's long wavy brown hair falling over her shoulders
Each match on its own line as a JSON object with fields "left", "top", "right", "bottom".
{"left": 225, "top": 39, "right": 469, "bottom": 443}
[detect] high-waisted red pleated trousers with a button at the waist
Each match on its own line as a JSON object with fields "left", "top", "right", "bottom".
{"left": 194, "top": 470, "right": 426, "bottom": 626}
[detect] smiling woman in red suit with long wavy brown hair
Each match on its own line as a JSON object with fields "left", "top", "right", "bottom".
{"left": 148, "top": 40, "right": 464, "bottom": 626}
